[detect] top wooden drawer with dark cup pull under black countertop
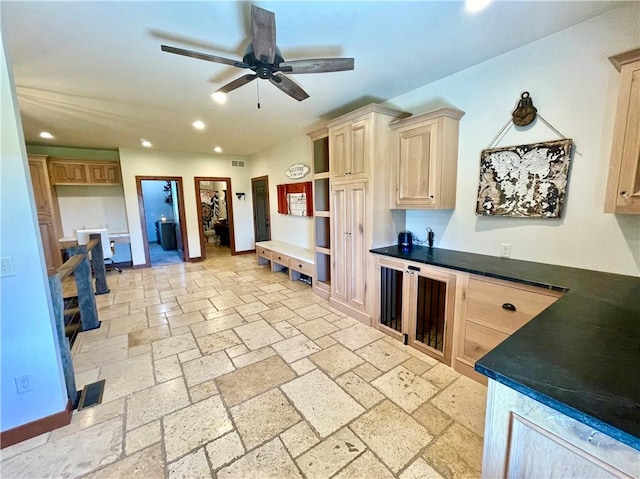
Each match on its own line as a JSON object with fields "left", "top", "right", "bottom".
{"left": 466, "top": 278, "right": 561, "bottom": 334}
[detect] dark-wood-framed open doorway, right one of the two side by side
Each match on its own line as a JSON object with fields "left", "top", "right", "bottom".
{"left": 194, "top": 176, "right": 236, "bottom": 259}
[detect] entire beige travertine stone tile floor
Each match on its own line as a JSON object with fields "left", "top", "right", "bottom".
{"left": 0, "top": 249, "right": 486, "bottom": 479}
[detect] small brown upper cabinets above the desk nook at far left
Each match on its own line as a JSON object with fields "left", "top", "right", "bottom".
{"left": 49, "top": 158, "right": 122, "bottom": 185}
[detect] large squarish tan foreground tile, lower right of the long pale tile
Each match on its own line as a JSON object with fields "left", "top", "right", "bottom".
{"left": 349, "top": 401, "right": 432, "bottom": 474}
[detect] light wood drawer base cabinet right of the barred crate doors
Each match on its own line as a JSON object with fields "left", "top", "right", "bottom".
{"left": 454, "top": 275, "right": 562, "bottom": 384}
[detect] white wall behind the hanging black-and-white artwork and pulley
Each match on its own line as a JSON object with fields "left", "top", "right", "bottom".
{"left": 389, "top": 2, "right": 640, "bottom": 275}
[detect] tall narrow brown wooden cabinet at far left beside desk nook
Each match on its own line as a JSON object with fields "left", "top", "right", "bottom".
{"left": 29, "top": 155, "right": 62, "bottom": 274}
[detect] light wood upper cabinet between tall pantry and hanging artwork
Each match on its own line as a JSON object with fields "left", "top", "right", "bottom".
{"left": 390, "top": 108, "right": 464, "bottom": 210}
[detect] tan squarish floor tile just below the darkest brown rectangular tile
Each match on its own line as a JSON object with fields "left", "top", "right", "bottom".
{"left": 230, "top": 389, "right": 301, "bottom": 449}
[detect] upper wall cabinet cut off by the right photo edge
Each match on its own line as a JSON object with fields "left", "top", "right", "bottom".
{"left": 604, "top": 49, "right": 640, "bottom": 214}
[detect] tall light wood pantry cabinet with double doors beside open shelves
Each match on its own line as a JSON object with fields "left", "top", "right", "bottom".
{"left": 327, "top": 104, "right": 409, "bottom": 325}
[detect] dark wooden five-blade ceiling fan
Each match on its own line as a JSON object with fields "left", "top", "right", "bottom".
{"left": 161, "top": 5, "right": 353, "bottom": 101}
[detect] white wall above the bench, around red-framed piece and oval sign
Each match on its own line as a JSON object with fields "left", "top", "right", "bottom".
{"left": 247, "top": 136, "right": 314, "bottom": 249}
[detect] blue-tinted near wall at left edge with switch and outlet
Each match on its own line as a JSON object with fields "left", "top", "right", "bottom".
{"left": 0, "top": 33, "right": 67, "bottom": 431}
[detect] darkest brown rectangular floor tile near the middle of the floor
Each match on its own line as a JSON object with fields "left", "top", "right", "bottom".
{"left": 216, "top": 356, "right": 296, "bottom": 407}
